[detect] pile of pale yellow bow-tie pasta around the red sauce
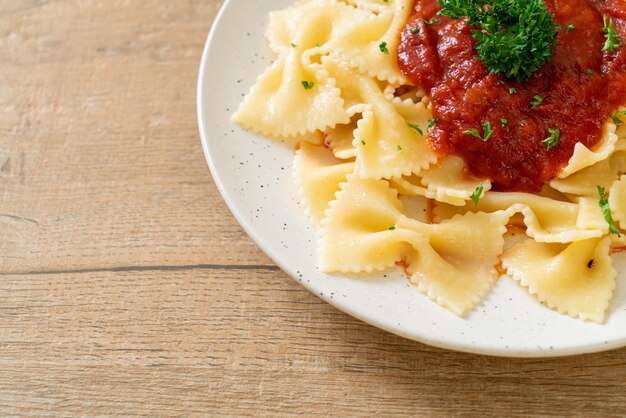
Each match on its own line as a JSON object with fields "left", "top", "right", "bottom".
{"left": 233, "top": 0, "right": 626, "bottom": 322}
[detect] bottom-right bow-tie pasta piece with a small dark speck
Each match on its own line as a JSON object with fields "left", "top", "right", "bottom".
{"left": 502, "top": 238, "right": 617, "bottom": 323}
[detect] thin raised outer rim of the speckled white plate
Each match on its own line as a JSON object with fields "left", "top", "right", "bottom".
{"left": 196, "top": 0, "right": 626, "bottom": 358}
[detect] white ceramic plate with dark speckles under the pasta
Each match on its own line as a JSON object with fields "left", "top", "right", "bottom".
{"left": 198, "top": 0, "right": 626, "bottom": 357}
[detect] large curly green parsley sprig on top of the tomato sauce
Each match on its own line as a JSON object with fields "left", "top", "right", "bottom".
{"left": 439, "top": 0, "right": 559, "bottom": 81}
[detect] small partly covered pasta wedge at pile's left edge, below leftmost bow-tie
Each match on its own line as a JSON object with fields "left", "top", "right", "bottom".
{"left": 293, "top": 143, "right": 354, "bottom": 227}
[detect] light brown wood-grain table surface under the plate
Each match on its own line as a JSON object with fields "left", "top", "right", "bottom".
{"left": 0, "top": 0, "right": 626, "bottom": 416}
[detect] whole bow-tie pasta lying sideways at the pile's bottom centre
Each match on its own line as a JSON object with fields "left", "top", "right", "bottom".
{"left": 320, "top": 175, "right": 508, "bottom": 315}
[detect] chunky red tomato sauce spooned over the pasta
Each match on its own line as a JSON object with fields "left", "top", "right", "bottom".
{"left": 398, "top": 0, "right": 626, "bottom": 192}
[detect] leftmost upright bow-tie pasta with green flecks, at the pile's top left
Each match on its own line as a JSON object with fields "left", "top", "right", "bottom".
{"left": 233, "top": 0, "right": 370, "bottom": 137}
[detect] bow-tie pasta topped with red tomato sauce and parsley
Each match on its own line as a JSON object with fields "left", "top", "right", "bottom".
{"left": 233, "top": 0, "right": 626, "bottom": 323}
